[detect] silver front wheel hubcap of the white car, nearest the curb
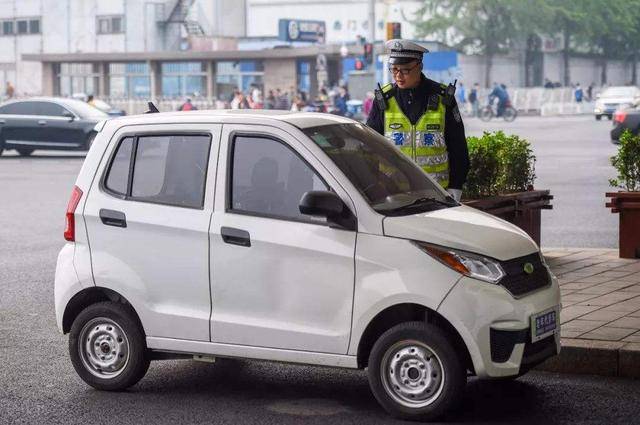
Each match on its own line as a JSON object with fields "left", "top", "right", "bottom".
{"left": 380, "top": 341, "right": 445, "bottom": 408}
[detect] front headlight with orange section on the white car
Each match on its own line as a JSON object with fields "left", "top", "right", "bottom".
{"left": 414, "top": 242, "right": 506, "bottom": 283}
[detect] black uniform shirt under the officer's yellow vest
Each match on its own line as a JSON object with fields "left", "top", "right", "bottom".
{"left": 367, "top": 75, "right": 469, "bottom": 189}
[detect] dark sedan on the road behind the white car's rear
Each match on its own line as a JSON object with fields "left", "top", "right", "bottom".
{"left": 0, "top": 97, "right": 109, "bottom": 156}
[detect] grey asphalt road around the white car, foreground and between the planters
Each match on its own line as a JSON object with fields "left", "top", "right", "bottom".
{"left": 0, "top": 118, "right": 640, "bottom": 424}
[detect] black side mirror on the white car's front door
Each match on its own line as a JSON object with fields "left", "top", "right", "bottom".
{"left": 299, "top": 190, "right": 357, "bottom": 230}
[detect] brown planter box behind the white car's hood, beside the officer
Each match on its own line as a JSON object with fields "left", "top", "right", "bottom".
{"left": 463, "top": 190, "right": 552, "bottom": 245}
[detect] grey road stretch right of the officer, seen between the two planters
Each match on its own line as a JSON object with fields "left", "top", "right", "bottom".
{"left": 465, "top": 116, "right": 618, "bottom": 248}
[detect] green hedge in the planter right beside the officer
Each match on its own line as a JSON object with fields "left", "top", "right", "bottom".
{"left": 464, "top": 131, "right": 536, "bottom": 199}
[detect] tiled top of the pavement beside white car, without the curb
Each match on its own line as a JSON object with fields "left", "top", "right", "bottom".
{"left": 544, "top": 249, "right": 640, "bottom": 343}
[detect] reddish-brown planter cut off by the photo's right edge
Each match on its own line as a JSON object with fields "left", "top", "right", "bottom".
{"left": 606, "top": 192, "right": 640, "bottom": 258}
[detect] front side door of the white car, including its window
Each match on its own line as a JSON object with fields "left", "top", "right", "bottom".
{"left": 210, "top": 124, "right": 356, "bottom": 354}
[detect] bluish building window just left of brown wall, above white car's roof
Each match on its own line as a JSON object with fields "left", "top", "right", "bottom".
{"left": 216, "top": 61, "right": 264, "bottom": 101}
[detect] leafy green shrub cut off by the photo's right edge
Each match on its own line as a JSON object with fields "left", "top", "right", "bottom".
{"left": 609, "top": 130, "right": 640, "bottom": 192}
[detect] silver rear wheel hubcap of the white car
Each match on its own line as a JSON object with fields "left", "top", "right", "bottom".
{"left": 78, "top": 317, "right": 129, "bottom": 379}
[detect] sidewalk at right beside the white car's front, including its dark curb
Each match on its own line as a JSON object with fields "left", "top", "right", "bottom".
{"left": 540, "top": 248, "right": 640, "bottom": 378}
